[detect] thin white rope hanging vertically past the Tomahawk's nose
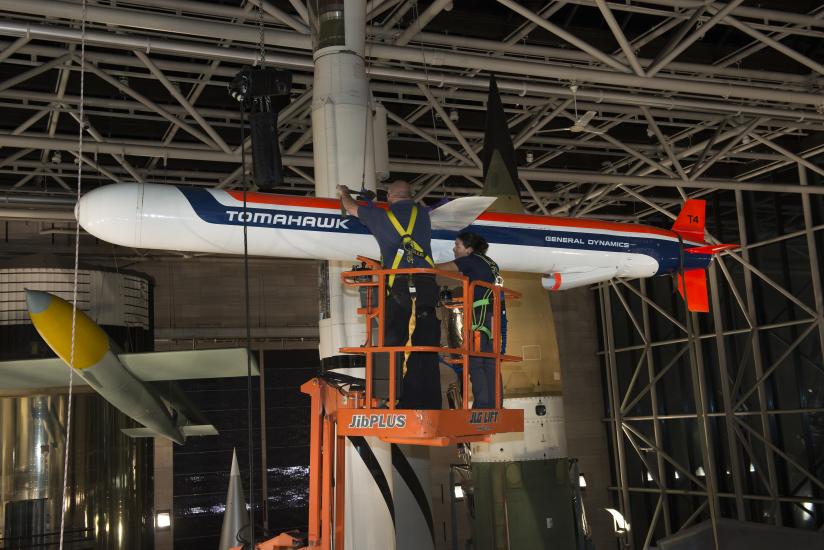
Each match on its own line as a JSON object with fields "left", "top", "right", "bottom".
{"left": 58, "top": 0, "right": 86, "bottom": 550}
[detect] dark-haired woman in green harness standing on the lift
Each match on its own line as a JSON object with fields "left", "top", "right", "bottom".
{"left": 435, "top": 231, "right": 506, "bottom": 409}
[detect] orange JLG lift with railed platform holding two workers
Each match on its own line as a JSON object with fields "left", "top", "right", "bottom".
{"left": 235, "top": 257, "right": 524, "bottom": 550}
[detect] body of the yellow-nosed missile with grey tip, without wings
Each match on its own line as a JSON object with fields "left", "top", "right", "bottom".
{"left": 26, "top": 290, "right": 184, "bottom": 443}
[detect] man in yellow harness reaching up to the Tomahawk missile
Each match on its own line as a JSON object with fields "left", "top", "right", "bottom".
{"left": 338, "top": 180, "right": 441, "bottom": 409}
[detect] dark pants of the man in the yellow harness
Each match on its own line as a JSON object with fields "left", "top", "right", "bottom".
{"left": 384, "top": 275, "right": 441, "bottom": 409}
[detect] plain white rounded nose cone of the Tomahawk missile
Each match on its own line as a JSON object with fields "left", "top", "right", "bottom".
{"left": 74, "top": 183, "right": 142, "bottom": 246}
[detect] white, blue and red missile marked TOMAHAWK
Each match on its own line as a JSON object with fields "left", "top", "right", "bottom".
{"left": 75, "top": 183, "right": 734, "bottom": 311}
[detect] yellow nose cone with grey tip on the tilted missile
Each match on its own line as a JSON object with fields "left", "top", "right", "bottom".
{"left": 26, "top": 290, "right": 109, "bottom": 369}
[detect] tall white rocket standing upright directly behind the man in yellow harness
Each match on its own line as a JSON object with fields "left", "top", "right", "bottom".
{"left": 309, "top": 0, "right": 434, "bottom": 550}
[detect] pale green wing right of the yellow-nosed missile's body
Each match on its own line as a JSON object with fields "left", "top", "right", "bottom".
{"left": 117, "top": 348, "right": 259, "bottom": 382}
